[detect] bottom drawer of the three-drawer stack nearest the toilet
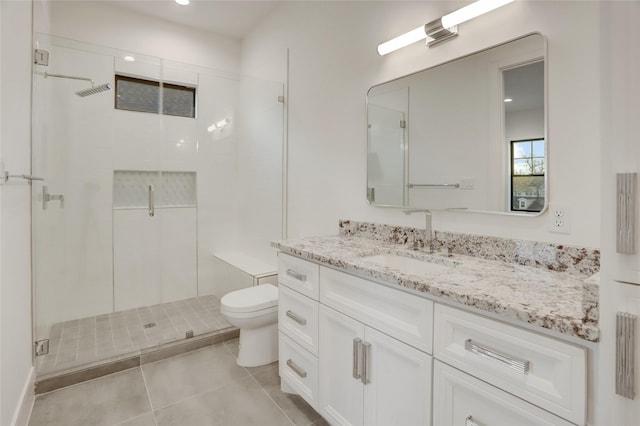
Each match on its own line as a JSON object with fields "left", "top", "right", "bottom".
{"left": 278, "top": 333, "right": 318, "bottom": 410}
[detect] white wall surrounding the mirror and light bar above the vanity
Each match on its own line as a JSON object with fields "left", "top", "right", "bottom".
{"left": 242, "top": 1, "right": 600, "bottom": 247}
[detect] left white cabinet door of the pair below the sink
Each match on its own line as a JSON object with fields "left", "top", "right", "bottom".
{"left": 318, "top": 305, "right": 364, "bottom": 425}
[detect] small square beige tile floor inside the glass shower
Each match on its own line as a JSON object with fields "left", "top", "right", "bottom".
{"left": 36, "top": 295, "right": 231, "bottom": 375}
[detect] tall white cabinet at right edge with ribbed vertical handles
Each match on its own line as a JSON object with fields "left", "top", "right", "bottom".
{"left": 594, "top": 2, "right": 640, "bottom": 426}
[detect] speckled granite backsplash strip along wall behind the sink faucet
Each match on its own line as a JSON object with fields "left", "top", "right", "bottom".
{"left": 339, "top": 220, "right": 600, "bottom": 277}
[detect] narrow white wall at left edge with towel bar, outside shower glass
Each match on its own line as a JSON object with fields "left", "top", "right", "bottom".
{"left": 0, "top": 1, "right": 33, "bottom": 426}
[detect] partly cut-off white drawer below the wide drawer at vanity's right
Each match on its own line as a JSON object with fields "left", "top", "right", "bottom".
{"left": 433, "top": 360, "right": 571, "bottom": 426}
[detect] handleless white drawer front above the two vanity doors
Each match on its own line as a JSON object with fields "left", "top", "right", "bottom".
{"left": 320, "top": 267, "right": 433, "bottom": 354}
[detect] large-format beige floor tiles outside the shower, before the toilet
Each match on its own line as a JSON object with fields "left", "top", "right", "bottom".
{"left": 29, "top": 339, "right": 327, "bottom": 426}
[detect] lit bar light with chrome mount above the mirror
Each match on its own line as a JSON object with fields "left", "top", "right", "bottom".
{"left": 378, "top": 0, "right": 514, "bottom": 56}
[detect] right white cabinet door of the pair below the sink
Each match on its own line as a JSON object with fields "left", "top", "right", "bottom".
{"left": 364, "top": 327, "right": 431, "bottom": 426}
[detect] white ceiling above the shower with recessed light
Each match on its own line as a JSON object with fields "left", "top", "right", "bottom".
{"left": 109, "top": 0, "right": 280, "bottom": 39}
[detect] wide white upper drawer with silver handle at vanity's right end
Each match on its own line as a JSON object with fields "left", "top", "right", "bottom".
{"left": 433, "top": 304, "right": 586, "bottom": 424}
